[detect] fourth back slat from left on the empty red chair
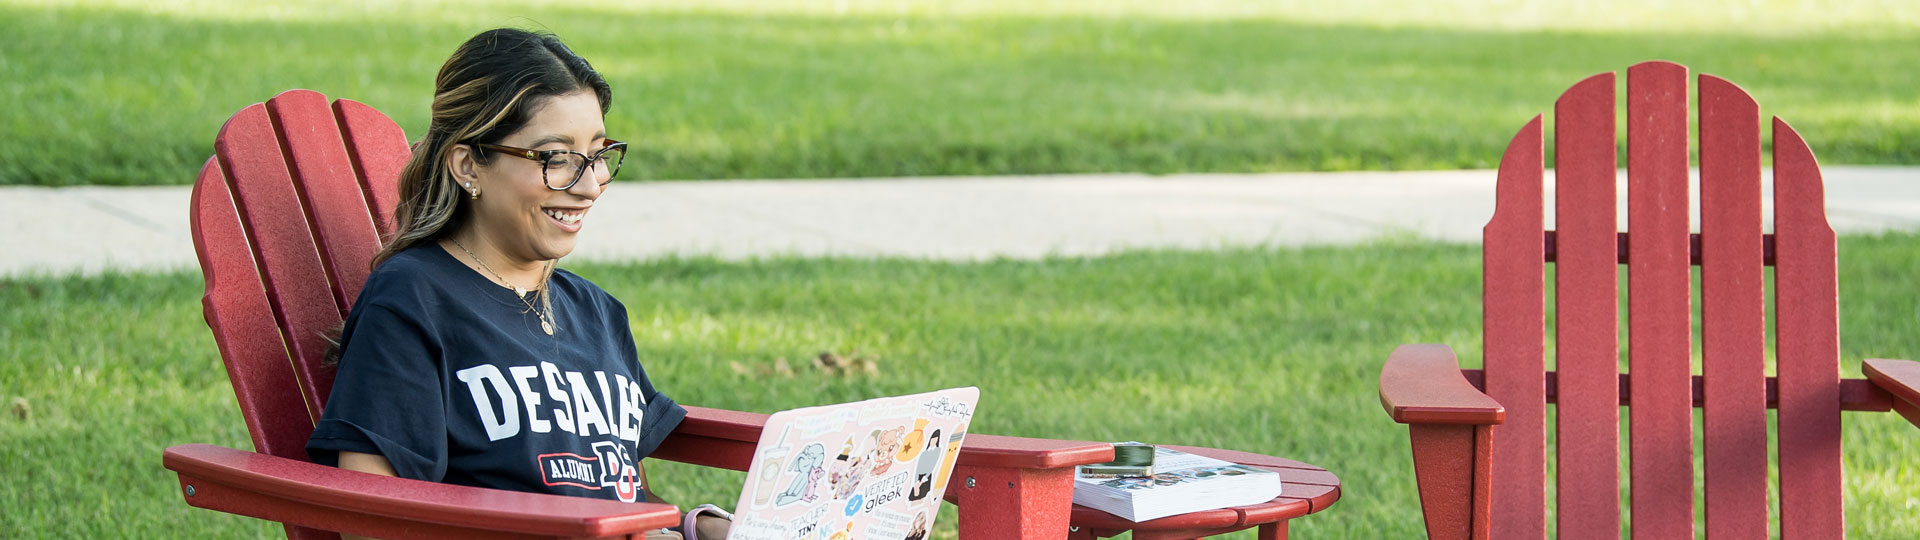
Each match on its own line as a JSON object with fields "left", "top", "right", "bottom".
{"left": 1699, "top": 75, "right": 1766, "bottom": 538}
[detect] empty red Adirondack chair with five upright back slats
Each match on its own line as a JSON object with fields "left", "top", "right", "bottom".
{"left": 1380, "top": 61, "right": 1920, "bottom": 538}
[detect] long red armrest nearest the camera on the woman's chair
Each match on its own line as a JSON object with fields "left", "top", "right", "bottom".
{"left": 161, "top": 444, "right": 680, "bottom": 538}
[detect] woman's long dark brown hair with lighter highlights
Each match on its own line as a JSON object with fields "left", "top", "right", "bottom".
{"left": 372, "top": 29, "right": 612, "bottom": 267}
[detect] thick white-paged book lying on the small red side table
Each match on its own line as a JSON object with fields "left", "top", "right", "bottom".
{"left": 1073, "top": 448, "right": 1281, "bottom": 523}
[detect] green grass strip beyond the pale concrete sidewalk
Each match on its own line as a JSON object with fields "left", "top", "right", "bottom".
{"left": 0, "top": 0, "right": 1920, "bottom": 184}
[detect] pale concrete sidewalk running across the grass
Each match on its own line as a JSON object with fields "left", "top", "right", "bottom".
{"left": 0, "top": 165, "right": 1920, "bottom": 277}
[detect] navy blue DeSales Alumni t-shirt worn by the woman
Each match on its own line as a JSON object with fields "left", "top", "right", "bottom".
{"left": 307, "top": 242, "right": 687, "bottom": 502}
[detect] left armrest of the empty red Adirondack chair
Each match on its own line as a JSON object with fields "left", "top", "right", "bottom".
{"left": 1380, "top": 344, "right": 1507, "bottom": 425}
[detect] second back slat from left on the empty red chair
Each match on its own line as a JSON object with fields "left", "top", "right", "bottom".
{"left": 1543, "top": 73, "right": 1620, "bottom": 540}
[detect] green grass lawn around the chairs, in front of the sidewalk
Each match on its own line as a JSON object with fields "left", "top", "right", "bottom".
{"left": 0, "top": 234, "right": 1920, "bottom": 538}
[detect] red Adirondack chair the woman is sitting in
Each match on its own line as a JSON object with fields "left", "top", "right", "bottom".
{"left": 163, "top": 90, "right": 1114, "bottom": 540}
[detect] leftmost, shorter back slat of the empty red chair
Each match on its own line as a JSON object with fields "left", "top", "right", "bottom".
{"left": 1480, "top": 115, "right": 1546, "bottom": 538}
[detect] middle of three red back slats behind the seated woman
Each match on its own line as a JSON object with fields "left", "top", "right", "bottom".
{"left": 267, "top": 90, "right": 380, "bottom": 319}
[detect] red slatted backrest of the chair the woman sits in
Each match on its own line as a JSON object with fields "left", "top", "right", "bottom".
{"left": 192, "top": 90, "right": 409, "bottom": 459}
